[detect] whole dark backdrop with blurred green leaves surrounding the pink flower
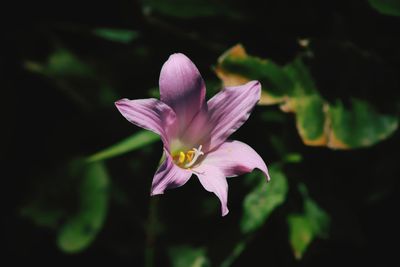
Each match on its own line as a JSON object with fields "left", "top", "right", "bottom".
{"left": 0, "top": 0, "right": 400, "bottom": 267}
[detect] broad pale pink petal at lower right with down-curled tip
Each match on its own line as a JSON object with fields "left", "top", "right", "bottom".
{"left": 201, "top": 140, "right": 270, "bottom": 181}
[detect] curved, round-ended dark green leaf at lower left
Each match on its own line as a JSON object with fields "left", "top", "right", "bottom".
{"left": 57, "top": 162, "right": 109, "bottom": 253}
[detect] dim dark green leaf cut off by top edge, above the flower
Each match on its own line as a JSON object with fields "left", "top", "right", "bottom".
{"left": 142, "top": 0, "right": 239, "bottom": 19}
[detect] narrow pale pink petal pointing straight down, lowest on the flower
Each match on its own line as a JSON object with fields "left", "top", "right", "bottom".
{"left": 194, "top": 164, "right": 229, "bottom": 216}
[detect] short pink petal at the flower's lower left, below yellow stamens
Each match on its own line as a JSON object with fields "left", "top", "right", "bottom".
{"left": 151, "top": 152, "right": 192, "bottom": 196}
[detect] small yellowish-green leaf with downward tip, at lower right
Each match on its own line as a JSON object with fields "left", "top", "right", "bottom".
{"left": 288, "top": 185, "right": 330, "bottom": 259}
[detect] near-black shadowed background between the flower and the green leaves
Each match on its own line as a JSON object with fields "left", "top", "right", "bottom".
{"left": 0, "top": 0, "right": 400, "bottom": 266}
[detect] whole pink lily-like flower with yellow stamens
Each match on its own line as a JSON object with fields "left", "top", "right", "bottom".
{"left": 115, "top": 54, "right": 269, "bottom": 216}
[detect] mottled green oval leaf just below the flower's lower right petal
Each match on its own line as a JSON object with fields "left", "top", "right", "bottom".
{"left": 240, "top": 166, "right": 288, "bottom": 233}
